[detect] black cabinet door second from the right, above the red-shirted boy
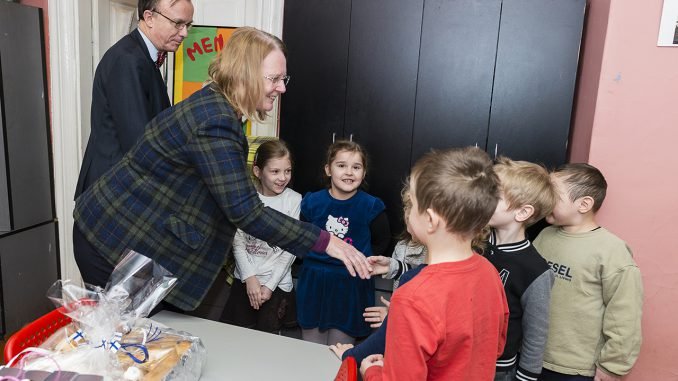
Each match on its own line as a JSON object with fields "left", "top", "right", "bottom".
{"left": 412, "top": 0, "right": 501, "bottom": 163}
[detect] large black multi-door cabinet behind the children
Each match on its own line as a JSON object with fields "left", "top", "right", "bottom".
{"left": 280, "top": 0, "right": 586, "bottom": 238}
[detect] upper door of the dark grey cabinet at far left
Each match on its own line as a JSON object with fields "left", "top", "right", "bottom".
{"left": 0, "top": 2, "right": 54, "bottom": 230}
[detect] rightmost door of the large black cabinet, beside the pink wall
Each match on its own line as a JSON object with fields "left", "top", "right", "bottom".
{"left": 487, "top": 0, "right": 586, "bottom": 166}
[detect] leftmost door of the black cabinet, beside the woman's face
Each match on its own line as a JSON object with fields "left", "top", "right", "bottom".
{"left": 280, "top": 0, "right": 351, "bottom": 195}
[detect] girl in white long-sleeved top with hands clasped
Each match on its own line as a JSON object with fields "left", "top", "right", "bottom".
{"left": 221, "top": 140, "right": 301, "bottom": 332}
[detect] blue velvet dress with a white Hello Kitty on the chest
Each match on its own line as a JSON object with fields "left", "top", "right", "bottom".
{"left": 297, "top": 189, "right": 385, "bottom": 337}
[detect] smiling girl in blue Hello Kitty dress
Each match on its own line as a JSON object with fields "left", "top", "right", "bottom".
{"left": 297, "top": 141, "right": 391, "bottom": 345}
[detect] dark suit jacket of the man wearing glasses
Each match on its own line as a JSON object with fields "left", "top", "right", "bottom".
{"left": 75, "top": 29, "right": 170, "bottom": 197}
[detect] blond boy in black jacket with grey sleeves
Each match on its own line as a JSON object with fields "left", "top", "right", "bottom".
{"left": 485, "top": 158, "right": 558, "bottom": 381}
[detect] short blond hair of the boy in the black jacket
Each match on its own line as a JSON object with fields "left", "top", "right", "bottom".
{"left": 494, "top": 156, "right": 558, "bottom": 226}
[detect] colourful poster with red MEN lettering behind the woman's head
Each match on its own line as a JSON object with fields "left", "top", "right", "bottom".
{"left": 172, "top": 25, "right": 236, "bottom": 104}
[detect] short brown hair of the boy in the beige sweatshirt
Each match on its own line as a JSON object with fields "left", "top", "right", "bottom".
{"left": 553, "top": 163, "right": 607, "bottom": 213}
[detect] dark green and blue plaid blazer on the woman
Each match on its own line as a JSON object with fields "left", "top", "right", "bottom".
{"left": 73, "top": 86, "right": 320, "bottom": 310}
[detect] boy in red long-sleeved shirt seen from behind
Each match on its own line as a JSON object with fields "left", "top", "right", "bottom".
{"left": 360, "top": 148, "right": 509, "bottom": 381}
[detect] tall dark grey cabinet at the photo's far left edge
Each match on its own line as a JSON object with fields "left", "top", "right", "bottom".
{"left": 0, "top": 1, "right": 59, "bottom": 335}
